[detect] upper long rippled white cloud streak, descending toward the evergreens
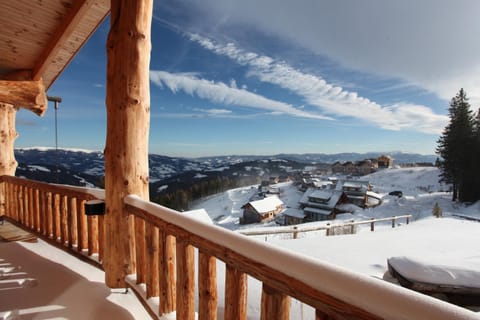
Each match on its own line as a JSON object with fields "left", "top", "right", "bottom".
{"left": 190, "top": 34, "right": 448, "bottom": 134}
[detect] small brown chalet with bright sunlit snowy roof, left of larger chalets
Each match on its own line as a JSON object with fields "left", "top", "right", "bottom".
{"left": 240, "top": 196, "right": 283, "bottom": 224}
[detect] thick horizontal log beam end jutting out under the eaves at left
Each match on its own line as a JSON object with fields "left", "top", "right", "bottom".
{"left": 0, "top": 80, "right": 48, "bottom": 116}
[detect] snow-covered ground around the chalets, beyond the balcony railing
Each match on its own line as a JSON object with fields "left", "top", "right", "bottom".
{"left": 194, "top": 167, "right": 480, "bottom": 319}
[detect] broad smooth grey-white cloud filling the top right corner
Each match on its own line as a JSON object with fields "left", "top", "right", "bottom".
{"left": 174, "top": 0, "right": 480, "bottom": 103}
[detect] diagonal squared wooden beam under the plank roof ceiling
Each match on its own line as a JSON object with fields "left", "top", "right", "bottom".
{"left": 32, "top": 0, "right": 95, "bottom": 80}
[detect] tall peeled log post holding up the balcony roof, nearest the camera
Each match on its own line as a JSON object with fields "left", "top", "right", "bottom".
{"left": 103, "top": 0, "right": 153, "bottom": 288}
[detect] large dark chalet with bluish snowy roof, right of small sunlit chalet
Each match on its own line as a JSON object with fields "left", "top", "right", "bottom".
{"left": 300, "top": 189, "right": 347, "bottom": 222}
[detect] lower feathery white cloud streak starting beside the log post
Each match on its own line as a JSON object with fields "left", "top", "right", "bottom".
{"left": 150, "top": 70, "right": 331, "bottom": 120}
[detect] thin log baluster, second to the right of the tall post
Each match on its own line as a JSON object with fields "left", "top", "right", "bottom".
{"left": 145, "top": 223, "right": 159, "bottom": 299}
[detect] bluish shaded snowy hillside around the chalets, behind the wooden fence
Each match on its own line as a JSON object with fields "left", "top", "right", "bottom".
{"left": 192, "top": 167, "right": 475, "bottom": 229}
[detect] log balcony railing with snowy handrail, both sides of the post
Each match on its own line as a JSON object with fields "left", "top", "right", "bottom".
{"left": 0, "top": 177, "right": 478, "bottom": 320}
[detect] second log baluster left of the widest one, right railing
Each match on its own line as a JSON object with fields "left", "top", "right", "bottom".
{"left": 198, "top": 250, "right": 218, "bottom": 320}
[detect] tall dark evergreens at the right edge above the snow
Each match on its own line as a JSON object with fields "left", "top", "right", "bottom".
{"left": 436, "top": 88, "right": 480, "bottom": 202}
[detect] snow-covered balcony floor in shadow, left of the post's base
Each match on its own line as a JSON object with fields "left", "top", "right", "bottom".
{"left": 0, "top": 239, "right": 150, "bottom": 320}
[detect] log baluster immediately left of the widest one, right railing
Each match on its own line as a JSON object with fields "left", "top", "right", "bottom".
{"left": 225, "top": 264, "right": 247, "bottom": 320}
